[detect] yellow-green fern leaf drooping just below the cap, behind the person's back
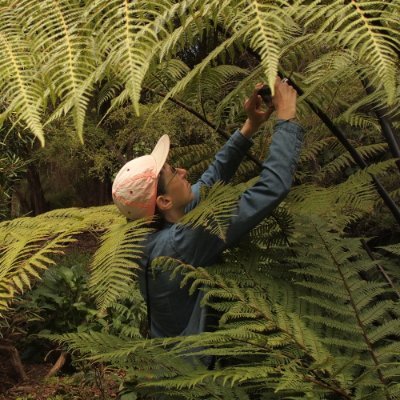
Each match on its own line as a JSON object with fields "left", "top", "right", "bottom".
{"left": 89, "top": 220, "right": 151, "bottom": 310}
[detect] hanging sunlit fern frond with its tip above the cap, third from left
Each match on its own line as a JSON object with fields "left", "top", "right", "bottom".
{"left": 87, "top": 0, "right": 200, "bottom": 114}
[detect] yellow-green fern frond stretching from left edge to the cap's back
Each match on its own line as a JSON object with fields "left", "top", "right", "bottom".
{"left": 0, "top": 207, "right": 122, "bottom": 313}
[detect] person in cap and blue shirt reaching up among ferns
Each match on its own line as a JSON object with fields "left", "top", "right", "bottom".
{"left": 113, "top": 77, "right": 303, "bottom": 344}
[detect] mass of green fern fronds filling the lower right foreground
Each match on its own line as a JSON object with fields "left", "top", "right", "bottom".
{"left": 42, "top": 212, "right": 400, "bottom": 399}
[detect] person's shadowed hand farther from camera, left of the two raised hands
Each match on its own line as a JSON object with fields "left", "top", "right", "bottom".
{"left": 240, "top": 83, "right": 274, "bottom": 138}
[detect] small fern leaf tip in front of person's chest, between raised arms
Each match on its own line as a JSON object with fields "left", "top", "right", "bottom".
{"left": 179, "top": 182, "right": 239, "bottom": 240}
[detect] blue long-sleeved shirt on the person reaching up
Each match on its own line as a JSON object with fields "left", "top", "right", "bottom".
{"left": 139, "top": 121, "right": 303, "bottom": 337}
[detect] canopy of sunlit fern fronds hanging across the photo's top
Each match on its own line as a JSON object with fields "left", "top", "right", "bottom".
{"left": 0, "top": 0, "right": 400, "bottom": 143}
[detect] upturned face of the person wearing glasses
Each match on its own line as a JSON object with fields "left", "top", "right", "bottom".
{"left": 160, "top": 163, "right": 194, "bottom": 209}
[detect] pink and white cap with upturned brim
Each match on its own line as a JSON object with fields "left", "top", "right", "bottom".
{"left": 112, "top": 135, "right": 170, "bottom": 219}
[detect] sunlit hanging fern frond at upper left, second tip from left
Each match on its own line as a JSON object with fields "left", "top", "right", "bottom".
{"left": 14, "top": 0, "right": 95, "bottom": 140}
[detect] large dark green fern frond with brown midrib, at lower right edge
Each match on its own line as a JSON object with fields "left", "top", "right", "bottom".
{"left": 293, "top": 217, "right": 400, "bottom": 399}
